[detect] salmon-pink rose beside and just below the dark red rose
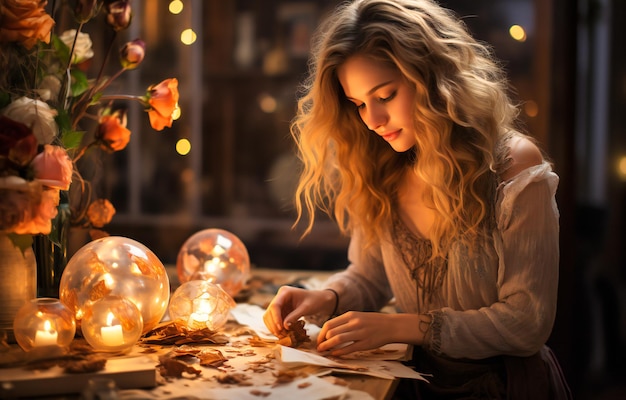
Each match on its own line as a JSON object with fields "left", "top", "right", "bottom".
{"left": 31, "top": 144, "right": 74, "bottom": 190}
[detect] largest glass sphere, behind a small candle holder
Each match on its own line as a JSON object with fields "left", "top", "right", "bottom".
{"left": 59, "top": 236, "right": 170, "bottom": 333}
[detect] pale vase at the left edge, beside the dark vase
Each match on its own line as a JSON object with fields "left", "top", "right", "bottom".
{"left": 0, "top": 234, "right": 37, "bottom": 343}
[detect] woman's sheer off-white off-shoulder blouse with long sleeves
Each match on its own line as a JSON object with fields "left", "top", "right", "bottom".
{"left": 325, "top": 162, "right": 559, "bottom": 359}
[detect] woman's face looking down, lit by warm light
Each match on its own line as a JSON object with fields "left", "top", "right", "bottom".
{"left": 337, "top": 55, "right": 415, "bottom": 152}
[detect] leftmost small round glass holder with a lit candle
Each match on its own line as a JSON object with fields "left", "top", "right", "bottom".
{"left": 13, "top": 297, "right": 76, "bottom": 353}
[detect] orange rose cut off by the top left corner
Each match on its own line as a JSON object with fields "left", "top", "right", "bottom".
{"left": 0, "top": 0, "right": 54, "bottom": 49}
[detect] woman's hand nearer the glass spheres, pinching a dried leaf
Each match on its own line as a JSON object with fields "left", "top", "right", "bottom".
{"left": 263, "top": 286, "right": 336, "bottom": 336}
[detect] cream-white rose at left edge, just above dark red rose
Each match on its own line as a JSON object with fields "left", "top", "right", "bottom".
{"left": 0, "top": 97, "right": 59, "bottom": 144}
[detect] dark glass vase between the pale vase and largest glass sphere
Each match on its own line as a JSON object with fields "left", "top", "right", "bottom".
{"left": 33, "top": 191, "right": 70, "bottom": 298}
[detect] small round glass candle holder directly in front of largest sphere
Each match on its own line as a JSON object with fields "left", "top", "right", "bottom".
{"left": 81, "top": 296, "right": 143, "bottom": 352}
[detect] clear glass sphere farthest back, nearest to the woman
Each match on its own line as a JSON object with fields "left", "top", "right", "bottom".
{"left": 176, "top": 228, "right": 250, "bottom": 297}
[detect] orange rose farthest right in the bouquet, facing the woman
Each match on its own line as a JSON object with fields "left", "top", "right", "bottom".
{"left": 147, "top": 78, "right": 179, "bottom": 131}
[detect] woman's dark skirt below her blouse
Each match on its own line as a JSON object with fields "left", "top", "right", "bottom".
{"left": 393, "top": 346, "right": 572, "bottom": 400}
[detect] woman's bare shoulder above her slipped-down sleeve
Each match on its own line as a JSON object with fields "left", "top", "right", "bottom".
{"left": 498, "top": 133, "right": 544, "bottom": 181}
